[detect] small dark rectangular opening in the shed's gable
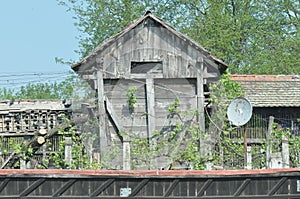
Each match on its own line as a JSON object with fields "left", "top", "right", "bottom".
{"left": 131, "top": 62, "right": 163, "bottom": 74}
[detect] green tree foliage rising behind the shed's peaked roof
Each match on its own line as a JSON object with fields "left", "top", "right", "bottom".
{"left": 59, "top": 0, "right": 300, "bottom": 74}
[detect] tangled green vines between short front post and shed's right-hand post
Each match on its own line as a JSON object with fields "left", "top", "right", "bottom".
{"left": 129, "top": 99, "right": 205, "bottom": 169}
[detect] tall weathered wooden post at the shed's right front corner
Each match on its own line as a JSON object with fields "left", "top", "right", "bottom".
{"left": 196, "top": 57, "right": 207, "bottom": 157}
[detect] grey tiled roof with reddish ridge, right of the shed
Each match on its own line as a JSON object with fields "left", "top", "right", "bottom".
{"left": 231, "top": 75, "right": 300, "bottom": 107}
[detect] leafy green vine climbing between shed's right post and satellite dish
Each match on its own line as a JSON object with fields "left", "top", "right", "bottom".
{"left": 206, "top": 70, "right": 244, "bottom": 168}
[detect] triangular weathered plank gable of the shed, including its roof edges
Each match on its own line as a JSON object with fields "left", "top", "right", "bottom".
{"left": 73, "top": 13, "right": 227, "bottom": 84}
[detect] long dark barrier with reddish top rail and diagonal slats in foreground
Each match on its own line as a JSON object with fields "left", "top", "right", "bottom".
{"left": 0, "top": 169, "right": 300, "bottom": 199}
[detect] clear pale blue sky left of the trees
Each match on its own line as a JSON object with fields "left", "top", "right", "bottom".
{"left": 0, "top": 0, "right": 79, "bottom": 86}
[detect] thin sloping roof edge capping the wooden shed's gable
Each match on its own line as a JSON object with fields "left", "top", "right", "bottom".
{"left": 72, "top": 11, "right": 228, "bottom": 71}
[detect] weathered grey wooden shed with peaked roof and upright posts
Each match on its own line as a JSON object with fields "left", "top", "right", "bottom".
{"left": 73, "top": 12, "right": 227, "bottom": 169}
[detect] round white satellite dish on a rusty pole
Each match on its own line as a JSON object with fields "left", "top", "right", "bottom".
{"left": 227, "top": 97, "right": 252, "bottom": 126}
